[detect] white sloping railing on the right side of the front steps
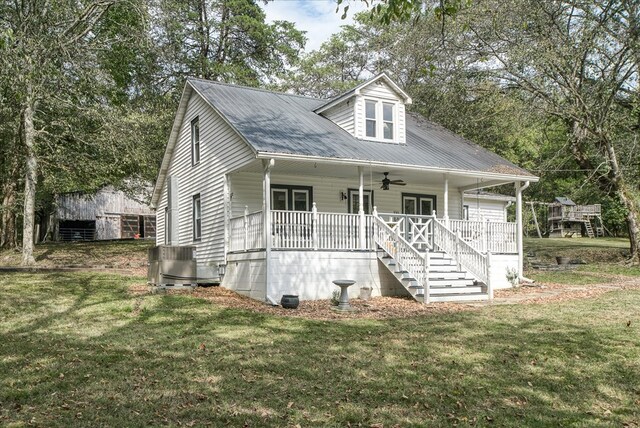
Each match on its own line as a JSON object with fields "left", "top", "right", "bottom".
{"left": 433, "top": 220, "right": 492, "bottom": 288}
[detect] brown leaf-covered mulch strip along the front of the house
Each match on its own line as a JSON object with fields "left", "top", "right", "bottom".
{"left": 130, "top": 275, "right": 640, "bottom": 320}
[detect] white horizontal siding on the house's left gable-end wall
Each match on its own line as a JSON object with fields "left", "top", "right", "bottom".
{"left": 156, "top": 92, "right": 255, "bottom": 270}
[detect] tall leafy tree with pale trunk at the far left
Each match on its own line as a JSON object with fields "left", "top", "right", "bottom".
{"left": 0, "top": 0, "right": 132, "bottom": 265}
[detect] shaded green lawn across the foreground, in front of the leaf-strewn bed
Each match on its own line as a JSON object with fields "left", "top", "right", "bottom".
{"left": 0, "top": 273, "right": 640, "bottom": 427}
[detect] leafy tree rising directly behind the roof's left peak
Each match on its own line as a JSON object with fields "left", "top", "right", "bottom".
{"left": 151, "top": 0, "right": 305, "bottom": 87}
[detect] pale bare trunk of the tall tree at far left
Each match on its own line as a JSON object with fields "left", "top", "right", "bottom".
{"left": 22, "top": 96, "right": 38, "bottom": 266}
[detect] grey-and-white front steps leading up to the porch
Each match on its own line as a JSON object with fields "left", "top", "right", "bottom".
{"left": 378, "top": 249, "right": 489, "bottom": 302}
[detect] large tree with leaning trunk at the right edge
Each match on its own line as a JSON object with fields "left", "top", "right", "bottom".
{"left": 458, "top": 0, "right": 640, "bottom": 262}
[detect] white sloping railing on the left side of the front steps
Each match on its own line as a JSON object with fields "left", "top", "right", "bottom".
{"left": 373, "top": 211, "right": 429, "bottom": 303}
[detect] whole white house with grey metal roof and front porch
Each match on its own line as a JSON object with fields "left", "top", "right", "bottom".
{"left": 152, "top": 73, "right": 538, "bottom": 302}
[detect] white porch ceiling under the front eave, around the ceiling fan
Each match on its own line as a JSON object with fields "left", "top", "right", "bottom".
{"left": 234, "top": 159, "right": 515, "bottom": 189}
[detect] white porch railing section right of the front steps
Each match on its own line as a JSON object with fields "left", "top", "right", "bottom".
{"left": 449, "top": 220, "right": 518, "bottom": 254}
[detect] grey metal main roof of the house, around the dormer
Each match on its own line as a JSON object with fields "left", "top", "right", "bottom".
{"left": 189, "top": 79, "right": 533, "bottom": 177}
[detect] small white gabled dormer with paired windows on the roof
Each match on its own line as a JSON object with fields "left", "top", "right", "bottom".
{"left": 315, "top": 73, "right": 411, "bottom": 144}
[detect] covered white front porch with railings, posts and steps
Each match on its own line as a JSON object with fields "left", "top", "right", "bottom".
{"left": 224, "top": 160, "right": 526, "bottom": 302}
